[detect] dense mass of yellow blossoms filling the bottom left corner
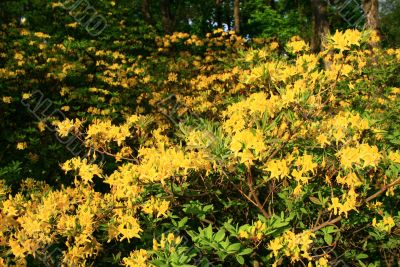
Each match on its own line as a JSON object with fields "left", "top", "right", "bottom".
{"left": 0, "top": 181, "right": 108, "bottom": 265}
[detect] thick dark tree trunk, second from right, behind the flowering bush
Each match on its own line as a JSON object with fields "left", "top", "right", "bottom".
{"left": 311, "top": 0, "right": 329, "bottom": 52}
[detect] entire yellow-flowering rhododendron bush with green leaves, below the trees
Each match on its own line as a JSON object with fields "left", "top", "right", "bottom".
{"left": 0, "top": 24, "right": 400, "bottom": 266}
